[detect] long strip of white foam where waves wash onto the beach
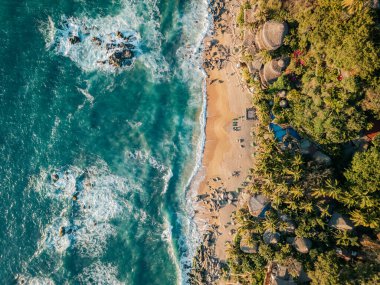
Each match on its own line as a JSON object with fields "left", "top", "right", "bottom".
{"left": 171, "top": 0, "right": 212, "bottom": 284}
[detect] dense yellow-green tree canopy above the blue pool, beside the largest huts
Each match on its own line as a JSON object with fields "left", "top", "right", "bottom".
{"left": 248, "top": 0, "right": 380, "bottom": 150}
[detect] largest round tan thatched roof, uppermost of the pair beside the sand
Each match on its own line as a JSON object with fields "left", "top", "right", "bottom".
{"left": 255, "top": 21, "right": 289, "bottom": 50}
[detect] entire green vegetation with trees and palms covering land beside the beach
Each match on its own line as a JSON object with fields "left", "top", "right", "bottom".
{"left": 226, "top": 0, "right": 380, "bottom": 285}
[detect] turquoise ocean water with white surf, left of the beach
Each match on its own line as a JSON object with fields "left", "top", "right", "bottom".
{"left": 0, "top": 0, "right": 208, "bottom": 284}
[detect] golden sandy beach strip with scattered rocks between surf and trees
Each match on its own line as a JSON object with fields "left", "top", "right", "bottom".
{"left": 196, "top": 1, "right": 255, "bottom": 268}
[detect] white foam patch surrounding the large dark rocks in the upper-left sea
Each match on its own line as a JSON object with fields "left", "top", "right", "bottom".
{"left": 40, "top": 0, "right": 169, "bottom": 79}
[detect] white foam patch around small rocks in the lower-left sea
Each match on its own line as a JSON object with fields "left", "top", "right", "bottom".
{"left": 31, "top": 162, "right": 133, "bottom": 257}
